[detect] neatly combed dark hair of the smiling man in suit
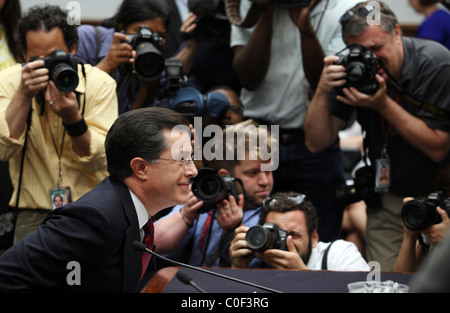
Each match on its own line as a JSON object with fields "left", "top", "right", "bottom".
{"left": 105, "top": 107, "right": 189, "bottom": 181}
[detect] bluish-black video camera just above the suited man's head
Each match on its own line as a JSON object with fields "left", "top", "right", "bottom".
{"left": 158, "top": 58, "right": 230, "bottom": 122}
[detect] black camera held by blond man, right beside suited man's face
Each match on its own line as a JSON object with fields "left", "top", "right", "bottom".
{"left": 192, "top": 167, "right": 245, "bottom": 212}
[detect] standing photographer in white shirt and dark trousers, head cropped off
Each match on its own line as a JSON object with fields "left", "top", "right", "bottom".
{"left": 231, "top": 0, "right": 359, "bottom": 240}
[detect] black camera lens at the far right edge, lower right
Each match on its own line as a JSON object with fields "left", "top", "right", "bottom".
{"left": 402, "top": 200, "right": 438, "bottom": 231}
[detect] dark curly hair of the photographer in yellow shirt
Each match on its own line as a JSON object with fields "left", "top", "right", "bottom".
{"left": 18, "top": 4, "right": 78, "bottom": 53}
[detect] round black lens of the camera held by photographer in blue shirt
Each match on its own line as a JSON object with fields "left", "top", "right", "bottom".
{"left": 134, "top": 41, "right": 164, "bottom": 82}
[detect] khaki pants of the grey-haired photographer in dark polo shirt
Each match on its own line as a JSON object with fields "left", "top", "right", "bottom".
{"left": 366, "top": 192, "right": 403, "bottom": 272}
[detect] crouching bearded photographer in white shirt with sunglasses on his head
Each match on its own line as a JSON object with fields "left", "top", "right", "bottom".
{"left": 229, "top": 193, "right": 370, "bottom": 271}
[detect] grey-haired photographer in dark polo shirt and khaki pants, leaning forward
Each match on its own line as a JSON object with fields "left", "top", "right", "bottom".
{"left": 305, "top": 2, "right": 450, "bottom": 271}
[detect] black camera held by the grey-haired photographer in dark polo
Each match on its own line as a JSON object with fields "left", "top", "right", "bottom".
{"left": 335, "top": 44, "right": 381, "bottom": 95}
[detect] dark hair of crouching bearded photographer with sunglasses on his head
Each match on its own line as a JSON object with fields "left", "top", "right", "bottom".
{"left": 259, "top": 192, "right": 319, "bottom": 238}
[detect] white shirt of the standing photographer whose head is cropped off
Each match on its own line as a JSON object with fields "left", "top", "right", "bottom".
{"left": 230, "top": 0, "right": 360, "bottom": 128}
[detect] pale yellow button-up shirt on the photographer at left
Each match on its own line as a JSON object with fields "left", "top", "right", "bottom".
{"left": 0, "top": 64, "right": 118, "bottom": 210}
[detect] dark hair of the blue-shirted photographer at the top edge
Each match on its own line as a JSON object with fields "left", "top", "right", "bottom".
{"left": 101, "top": 0, "right": 173, "bottom": 31}
